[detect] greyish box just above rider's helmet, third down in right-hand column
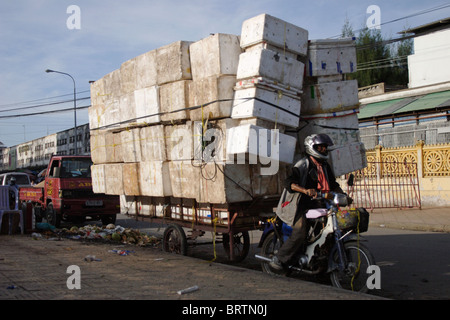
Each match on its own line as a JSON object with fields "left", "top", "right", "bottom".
{"left": 298, "top": 111, "right": 360, "bottom": 152}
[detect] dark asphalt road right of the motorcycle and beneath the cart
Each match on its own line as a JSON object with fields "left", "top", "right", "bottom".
{"left": 117, "top": 215, "right": 450, "bottom": 300}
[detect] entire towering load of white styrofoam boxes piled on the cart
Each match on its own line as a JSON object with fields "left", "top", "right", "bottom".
{"left": 89, "top": 14, "right": 366, "bottom": 221}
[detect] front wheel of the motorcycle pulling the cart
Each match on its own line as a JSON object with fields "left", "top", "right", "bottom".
{"left": 331, "top": 241, "right": 375, "bottom": 293}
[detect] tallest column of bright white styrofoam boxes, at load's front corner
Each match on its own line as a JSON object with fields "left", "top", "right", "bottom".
{"left": 228, "top": 14, "right": 308, "bottom": 163}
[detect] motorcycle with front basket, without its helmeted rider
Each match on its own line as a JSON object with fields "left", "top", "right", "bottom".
{"left": 255, "top": 176, "right": 375, "bottom": 292}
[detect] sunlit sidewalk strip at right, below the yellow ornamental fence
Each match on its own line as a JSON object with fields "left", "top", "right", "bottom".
{"left": 369, "top": 207, "right": 450, "bottom": 232}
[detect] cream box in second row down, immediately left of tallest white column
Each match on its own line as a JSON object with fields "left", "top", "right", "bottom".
{"left": 189, "top": 76, "right": 236, "bottom": 120}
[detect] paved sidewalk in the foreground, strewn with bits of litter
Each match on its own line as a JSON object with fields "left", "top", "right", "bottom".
{"left": 0, "top": 235, "right": 382, "bottom": 300}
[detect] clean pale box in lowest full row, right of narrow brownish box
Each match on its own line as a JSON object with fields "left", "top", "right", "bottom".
{"left": 139, "top": 161, "right": 172, "bottom": 197}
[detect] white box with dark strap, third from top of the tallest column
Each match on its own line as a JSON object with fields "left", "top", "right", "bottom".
{"left": 231, "top": 87, "right": 301, "bottom": 128}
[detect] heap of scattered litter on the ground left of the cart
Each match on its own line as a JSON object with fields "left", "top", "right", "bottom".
{"left": 32, "top": 224, "right": 159, "bottom": 246}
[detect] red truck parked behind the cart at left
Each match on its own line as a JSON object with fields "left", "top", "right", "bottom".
{"left": 19, "top": 156, "right": 120, "bottom": 227}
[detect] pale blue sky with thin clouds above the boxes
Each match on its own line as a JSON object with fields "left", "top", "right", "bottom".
{"left": 0, "top": 0, "right": 450, "bottom": 147}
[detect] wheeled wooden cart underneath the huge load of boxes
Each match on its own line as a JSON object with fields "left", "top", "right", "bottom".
{"left": 128, "top": 195, "right": 280, "bottom": 262}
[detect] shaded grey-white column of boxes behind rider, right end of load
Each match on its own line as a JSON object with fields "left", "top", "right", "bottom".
{"left": 298, "top": 39, "right": 367, "bottom": 176}
